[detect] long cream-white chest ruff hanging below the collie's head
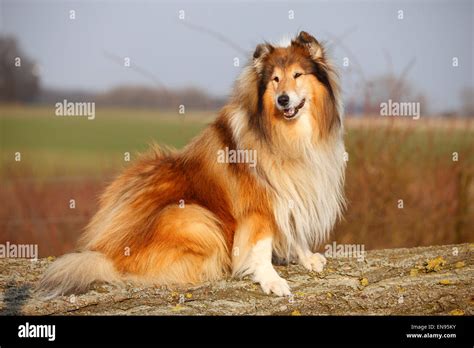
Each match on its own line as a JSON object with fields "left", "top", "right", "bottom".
{"left": 271, "top": 140, "right": 345, "bottom": 258}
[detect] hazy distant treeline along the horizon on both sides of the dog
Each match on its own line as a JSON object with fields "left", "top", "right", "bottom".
{"left": 0, "top": 36, "right": 474, "bottom": 117}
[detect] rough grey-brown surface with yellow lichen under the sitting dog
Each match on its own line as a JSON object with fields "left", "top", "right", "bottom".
{"left": 0, "top": 244, "right": 474, "bottom": 315}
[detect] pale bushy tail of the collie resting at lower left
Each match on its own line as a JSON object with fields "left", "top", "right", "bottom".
{"left": 37, "top": 251, "right": 120, "bottom": 298}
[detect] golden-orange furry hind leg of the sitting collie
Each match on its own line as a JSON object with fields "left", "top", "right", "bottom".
{"left": 110, "top": 204, "right": 230, "bottom": 285}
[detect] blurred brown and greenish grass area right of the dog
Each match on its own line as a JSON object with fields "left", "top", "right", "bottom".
{"left": 333, "top": 118, "right": 474, "bottom": 249}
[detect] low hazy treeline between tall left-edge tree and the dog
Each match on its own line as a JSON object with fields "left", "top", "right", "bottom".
{"left": 36, "top": 86, "right": 226, "bottom": 110}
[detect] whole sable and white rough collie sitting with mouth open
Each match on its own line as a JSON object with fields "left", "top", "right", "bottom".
{"left": 40, "top": 32, "right": 345, "bottom": 296}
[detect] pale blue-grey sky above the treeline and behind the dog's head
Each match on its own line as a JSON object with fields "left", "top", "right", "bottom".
{"left": 1, "top": 0, "right": 473, "bottom": 111}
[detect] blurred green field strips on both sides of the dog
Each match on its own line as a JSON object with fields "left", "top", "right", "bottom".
{"left": 0, "top": 106, "right": 474, "bottom": 176}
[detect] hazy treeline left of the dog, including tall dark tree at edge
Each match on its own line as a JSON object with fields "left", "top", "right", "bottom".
{"left": 0, "top": 35, "right": 225, "bottom": 109}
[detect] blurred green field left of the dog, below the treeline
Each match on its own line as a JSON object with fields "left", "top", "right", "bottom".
{"left": 0, "top": 107, "right": 214, "bottom": 175}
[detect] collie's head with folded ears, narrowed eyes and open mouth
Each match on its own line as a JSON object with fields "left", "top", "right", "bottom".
{"left": 236, "top": 31, "right": 341, "bottom": 145}
